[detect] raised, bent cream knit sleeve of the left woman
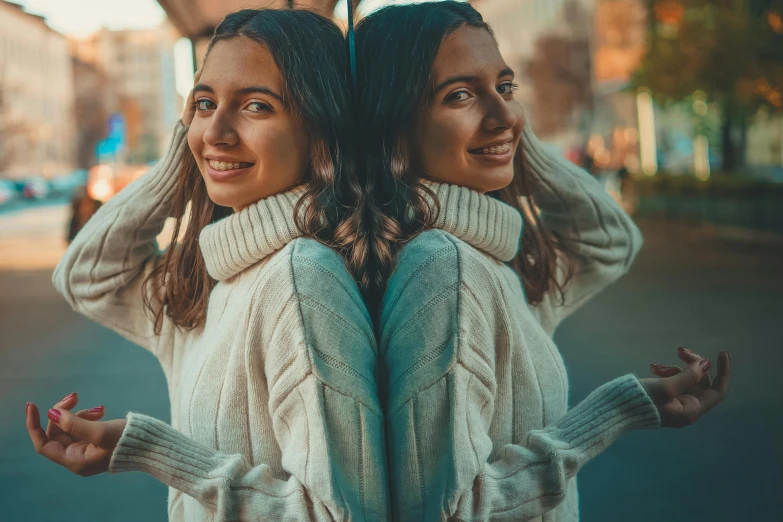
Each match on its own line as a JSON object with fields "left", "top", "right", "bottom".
{"left": 52, "top": 123, "right": 190, "bottom": 366}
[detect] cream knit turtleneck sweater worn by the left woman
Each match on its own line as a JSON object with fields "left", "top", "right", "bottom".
{"left": 53, "top": 124, "right": 388, "bottom": 522}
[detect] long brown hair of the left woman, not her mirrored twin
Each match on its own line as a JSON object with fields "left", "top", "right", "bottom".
{"left": 144, "top": 9, "right": 360, "bottom": 333}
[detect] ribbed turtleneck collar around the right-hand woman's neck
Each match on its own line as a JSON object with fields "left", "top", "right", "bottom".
{"left": 426, "top": 181, "right": 523, "bottom": 262}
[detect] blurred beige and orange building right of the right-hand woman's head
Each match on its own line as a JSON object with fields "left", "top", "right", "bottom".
{"left": 472, "top": 0, "right": 654, "bottom": 168}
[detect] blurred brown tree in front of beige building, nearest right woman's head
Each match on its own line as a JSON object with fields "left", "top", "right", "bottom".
{"left": 525, "top": 0, "right": 593, "bottom": 136}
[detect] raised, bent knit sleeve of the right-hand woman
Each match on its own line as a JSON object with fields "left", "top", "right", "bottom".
{"left": 522, "top": 124, "right": 642, "bottom": 335}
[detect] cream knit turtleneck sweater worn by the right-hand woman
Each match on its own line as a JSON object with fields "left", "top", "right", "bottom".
{"left": 379, "top": 128, "right": 660, "bottom": 522}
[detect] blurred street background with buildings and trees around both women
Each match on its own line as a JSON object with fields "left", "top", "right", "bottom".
{"left": 0, "top": 0, "right": 783, "bottom": 522}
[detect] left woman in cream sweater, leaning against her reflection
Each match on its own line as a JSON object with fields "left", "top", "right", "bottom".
{"left": 27, "top": 10, "right": 388, "bottom": 522}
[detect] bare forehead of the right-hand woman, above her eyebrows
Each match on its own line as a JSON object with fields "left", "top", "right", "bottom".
{"left": 432, "top": 26, "right": 508, "bottom": 84}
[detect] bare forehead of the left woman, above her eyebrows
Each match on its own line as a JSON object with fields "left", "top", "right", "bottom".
{"left": 200, "top": 36, "right": 283, "bottom": 92}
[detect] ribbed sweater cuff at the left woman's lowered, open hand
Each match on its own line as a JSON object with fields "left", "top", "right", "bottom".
{"left": 109, "top": 412, "right": 221, "bottom": 493}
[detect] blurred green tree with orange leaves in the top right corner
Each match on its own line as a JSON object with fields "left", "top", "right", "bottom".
{"left": 631, "top": 0, "right": 783, "bottom": 171}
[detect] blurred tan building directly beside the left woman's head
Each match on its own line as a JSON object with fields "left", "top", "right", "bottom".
{"left": 71, "top": 24, "right": 183, "bottom": 163}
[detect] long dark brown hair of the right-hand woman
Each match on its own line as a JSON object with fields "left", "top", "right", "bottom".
{"left": 356, "top": 1, "right": 577, "bottom": 305}
